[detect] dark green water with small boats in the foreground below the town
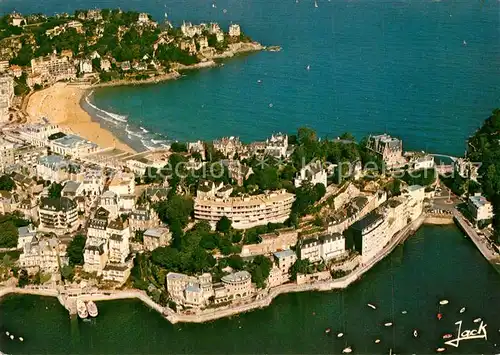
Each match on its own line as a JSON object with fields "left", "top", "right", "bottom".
{"left": 0, "top": 226, "right": 500, "bottom": 355}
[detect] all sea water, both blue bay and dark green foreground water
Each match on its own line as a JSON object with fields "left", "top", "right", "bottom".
{"left": 0, "top": 0, "right": 500, "bottom": 354}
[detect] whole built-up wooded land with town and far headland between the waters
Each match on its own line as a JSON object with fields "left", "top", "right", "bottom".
{"left": 0, "top": 10, "right": 500, "bottom": 322}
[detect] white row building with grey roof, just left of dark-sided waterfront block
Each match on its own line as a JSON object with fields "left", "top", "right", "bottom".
{"left": 300, "top": 233, "right": 346, "bottom": 263}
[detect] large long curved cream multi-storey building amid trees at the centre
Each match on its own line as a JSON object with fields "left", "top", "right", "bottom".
{"left": 194, "top": 190, "right": 295, "bottom": 229}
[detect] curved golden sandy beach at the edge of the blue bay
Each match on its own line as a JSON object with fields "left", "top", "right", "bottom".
{"left": 26, "top": 83, "right": 135, "bottom": 152}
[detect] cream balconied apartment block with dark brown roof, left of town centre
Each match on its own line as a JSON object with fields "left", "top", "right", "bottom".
{"left": 38, "top": 197, "right": 80, "bottom": 233}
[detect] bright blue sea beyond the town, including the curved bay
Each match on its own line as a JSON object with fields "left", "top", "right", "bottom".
{"left": 0, "top": 0, "right": 500, "bottom": 154}
